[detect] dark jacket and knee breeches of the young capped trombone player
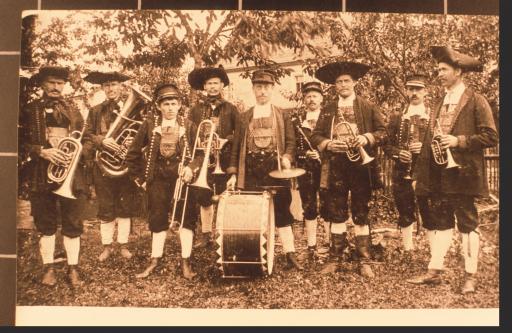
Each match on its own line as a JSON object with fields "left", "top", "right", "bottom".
{"left": 126, "top": 118, "right": 200, "bottom": 232}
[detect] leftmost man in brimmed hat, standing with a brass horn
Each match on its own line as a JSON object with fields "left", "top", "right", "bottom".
{"left": 20, "top": 66, "right": 88, "bottom": 286}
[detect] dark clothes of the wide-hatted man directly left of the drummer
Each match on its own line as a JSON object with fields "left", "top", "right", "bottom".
{"left": 189, "top": 98, "right": 238, "bottom": 207}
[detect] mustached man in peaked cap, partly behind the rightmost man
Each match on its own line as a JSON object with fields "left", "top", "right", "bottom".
{"left": 384, "top": 73, "right": 429, "bottom": 254}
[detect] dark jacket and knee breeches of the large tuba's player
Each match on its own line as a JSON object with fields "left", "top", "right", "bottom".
{"left": 88, "top": 101, "right": 140, "bottom": 222}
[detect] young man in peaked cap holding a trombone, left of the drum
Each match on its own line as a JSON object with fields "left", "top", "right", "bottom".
{"left": 126, "top": 83, "right": 201, "bottom": 279}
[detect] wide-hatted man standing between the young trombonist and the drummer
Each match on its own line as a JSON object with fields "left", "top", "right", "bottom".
{"left": 188, "top": 67, "right": 239, "bottom": 247}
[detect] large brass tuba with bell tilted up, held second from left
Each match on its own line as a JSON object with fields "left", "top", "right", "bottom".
{"left": 96, "top": 86, "right": 151, "bottom": 177}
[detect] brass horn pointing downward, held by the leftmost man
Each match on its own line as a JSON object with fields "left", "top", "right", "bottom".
{"left": 48, "top": 125, "right": 85, "bottom": 199}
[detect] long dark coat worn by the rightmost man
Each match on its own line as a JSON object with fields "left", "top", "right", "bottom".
{"left": 414, "top": 88, "right": 498, "bottom": 196}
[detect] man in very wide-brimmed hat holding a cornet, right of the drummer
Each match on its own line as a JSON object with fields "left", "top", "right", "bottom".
{"left": 311, "top": 62, "right": 386, "bottom": 278}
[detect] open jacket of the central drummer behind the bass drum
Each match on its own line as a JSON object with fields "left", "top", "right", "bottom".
{"left": 227, "top": 105, "right": 295, "bottom": 188}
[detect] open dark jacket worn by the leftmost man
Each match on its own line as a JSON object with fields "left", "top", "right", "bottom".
{"left": 19, "top": 99, "right": 90, "bottom": 193}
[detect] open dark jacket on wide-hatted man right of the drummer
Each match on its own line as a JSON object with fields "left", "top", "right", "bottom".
{"left": 311, "top": 96, "right": 387, "bottom": 188}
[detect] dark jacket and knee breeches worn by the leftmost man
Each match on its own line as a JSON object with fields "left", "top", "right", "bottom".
{"left": 21, "top": 100, "right": 86, "bottom": 238}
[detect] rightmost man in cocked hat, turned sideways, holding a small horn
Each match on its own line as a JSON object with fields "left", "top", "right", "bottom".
{"left": 408, "top": 46, "right": 498, "bottom": 294}
